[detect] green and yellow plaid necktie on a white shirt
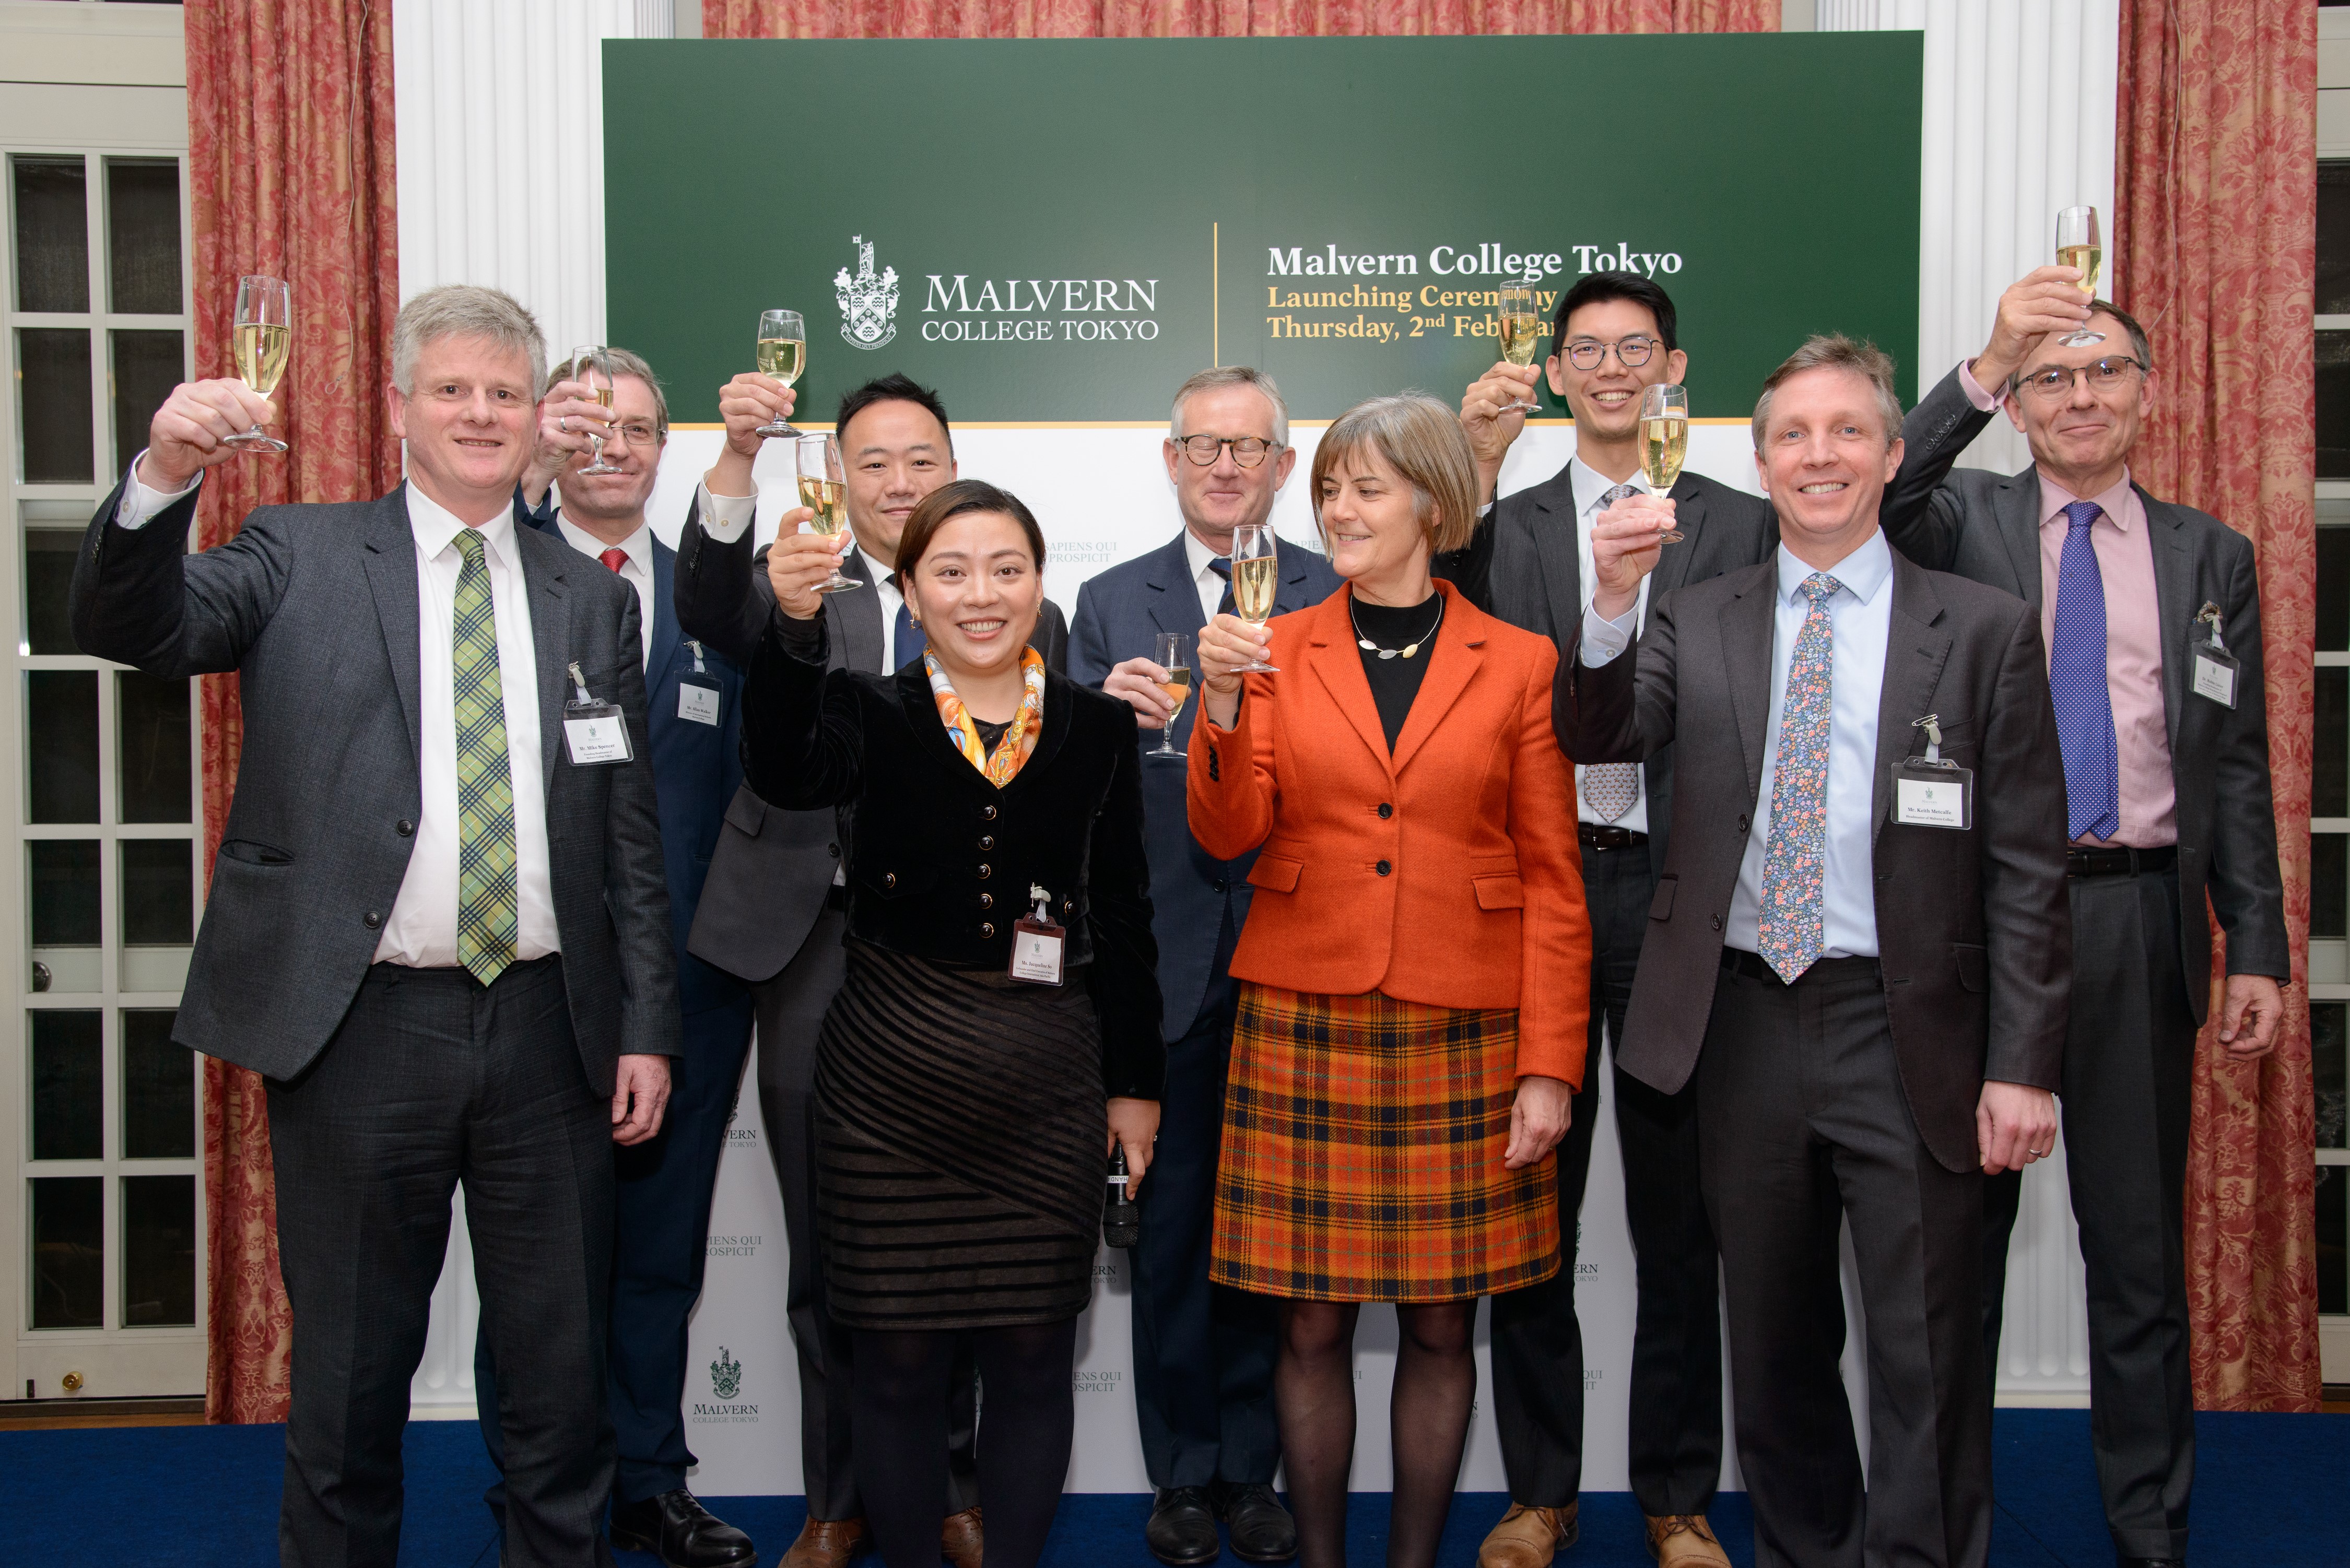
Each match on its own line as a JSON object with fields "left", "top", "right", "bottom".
{"left": 449, "top": 529, "right": 520, "bottom": 985}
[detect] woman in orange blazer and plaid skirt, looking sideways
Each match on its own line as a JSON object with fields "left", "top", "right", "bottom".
{"left": 1189, "top": 395, "right": 1591, "bottom": 1568}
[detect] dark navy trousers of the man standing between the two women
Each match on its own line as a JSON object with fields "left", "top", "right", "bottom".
{"left": 1133, "top": 917, "right": 1281, "bottom": 1488}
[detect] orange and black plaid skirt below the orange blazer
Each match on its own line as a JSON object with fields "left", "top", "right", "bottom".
{"left": 1211, "top": 983, "right": 1558, "bottom": 1302}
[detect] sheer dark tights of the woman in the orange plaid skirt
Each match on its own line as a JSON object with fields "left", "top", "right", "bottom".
{"left": 1278, "top": 1300, "right": 1476, "bottom": 1568}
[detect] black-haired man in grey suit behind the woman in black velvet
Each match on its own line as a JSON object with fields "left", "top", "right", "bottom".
{"left": 675, "top": 371, "right": 1070, "bottom": 1568}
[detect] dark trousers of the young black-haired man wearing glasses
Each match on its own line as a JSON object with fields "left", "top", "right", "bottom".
{"left": 1493, "top": 846, "right": 1723, "bottom": 1514}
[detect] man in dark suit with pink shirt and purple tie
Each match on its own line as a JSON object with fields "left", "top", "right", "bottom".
{"left": 1887, "top": 268, "right": 2292, "bottom": 1565}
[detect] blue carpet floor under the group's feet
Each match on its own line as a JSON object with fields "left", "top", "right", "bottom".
{"left": 0, "top": 1410, "right": 2350, "bottom": 1568}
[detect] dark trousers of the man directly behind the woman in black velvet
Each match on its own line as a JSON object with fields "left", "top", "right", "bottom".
{"left": 750, "top": 907, "right": 980, "bottom": 1518}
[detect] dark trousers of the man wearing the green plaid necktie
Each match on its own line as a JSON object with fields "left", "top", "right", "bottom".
{"left": 268, "top": 957, "right": 614, "bottom": 1568}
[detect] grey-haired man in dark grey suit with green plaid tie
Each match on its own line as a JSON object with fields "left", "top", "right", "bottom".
{"left": 73, "top": 285, "right": 677, "bottom": 1568}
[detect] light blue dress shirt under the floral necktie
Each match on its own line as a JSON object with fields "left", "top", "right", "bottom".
{"left": 1584, "top": 532, "right": 1894, "bottom": 959}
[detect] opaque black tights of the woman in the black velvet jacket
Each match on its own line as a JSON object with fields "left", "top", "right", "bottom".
{"left": 851, "top": 1316, "right": 1076, "bottom": 1568}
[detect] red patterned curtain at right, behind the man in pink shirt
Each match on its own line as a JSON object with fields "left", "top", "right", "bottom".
{"left": 2113, "top": 0, "right": 2322, "bottom": 1410}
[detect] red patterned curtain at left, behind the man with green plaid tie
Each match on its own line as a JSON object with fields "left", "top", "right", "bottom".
{"left": 188, "top": 0, "right": 400, "bottom": 1422}
